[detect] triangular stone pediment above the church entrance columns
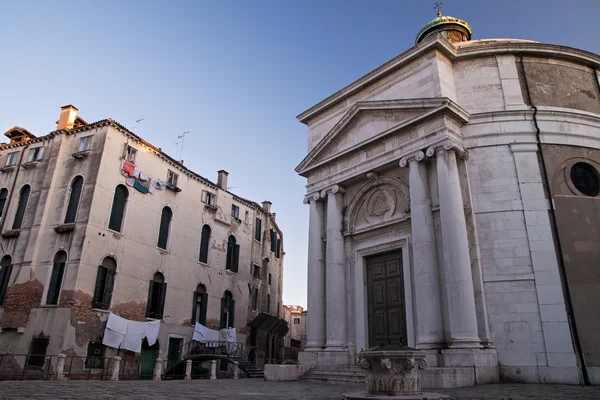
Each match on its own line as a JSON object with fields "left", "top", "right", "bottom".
{"left": 296, "top": 98, "right": 468, "bottom": 175}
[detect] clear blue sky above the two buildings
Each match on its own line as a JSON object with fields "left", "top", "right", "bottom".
{"left": 0, "top": 0, "right": 600, "bottom": 305}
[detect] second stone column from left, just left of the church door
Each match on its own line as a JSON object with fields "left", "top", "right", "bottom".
{"left": 324, "top": 185, "right": 346, "bottom": 351}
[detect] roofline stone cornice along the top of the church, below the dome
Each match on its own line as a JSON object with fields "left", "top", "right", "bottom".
{"left": 296, "top": 35, "right": 600, "bottom": 124}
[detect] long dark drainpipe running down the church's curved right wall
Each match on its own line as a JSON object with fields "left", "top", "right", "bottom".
{"left": 519, "top": 54, "right": 600, "bottom": 385}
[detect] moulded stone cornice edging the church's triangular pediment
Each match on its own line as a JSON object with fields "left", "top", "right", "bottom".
{"left": 296, "top": 97, "right": 470, "bottom": 175}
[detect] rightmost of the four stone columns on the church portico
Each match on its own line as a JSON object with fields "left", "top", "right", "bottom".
{"left": 427, "top": 140, "right": 481, "bottom": 348}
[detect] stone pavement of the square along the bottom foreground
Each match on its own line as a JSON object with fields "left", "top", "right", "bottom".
{"left": 0, "top": 379, "right": 600, "bottom": 400}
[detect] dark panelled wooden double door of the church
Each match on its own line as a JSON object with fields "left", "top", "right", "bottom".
{"left": 366, "top": 250, "right": 406, "bottom": 347}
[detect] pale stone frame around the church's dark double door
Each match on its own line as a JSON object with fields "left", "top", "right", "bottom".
{"left": 353, "top": 235, "right": 415, "bottom": 354}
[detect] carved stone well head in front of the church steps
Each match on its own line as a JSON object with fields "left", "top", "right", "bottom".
{"left": 358, "top": 344, "right": 427, "bottom": 396}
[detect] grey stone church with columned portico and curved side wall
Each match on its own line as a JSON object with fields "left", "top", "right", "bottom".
{"left": 296, "top": 14, "right": 600, "bottom": 387}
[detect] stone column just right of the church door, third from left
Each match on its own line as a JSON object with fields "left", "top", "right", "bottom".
{"left": 400, "top": 151, "right": 445, "bottom": 349}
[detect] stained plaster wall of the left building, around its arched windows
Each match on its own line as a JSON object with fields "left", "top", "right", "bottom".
{"left": 0, "top": 112, "right": 285, "bottom": 368}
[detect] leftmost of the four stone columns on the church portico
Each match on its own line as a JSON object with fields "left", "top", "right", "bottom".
{"left": 304, "top": 193, "right": 325, "bottom": 351}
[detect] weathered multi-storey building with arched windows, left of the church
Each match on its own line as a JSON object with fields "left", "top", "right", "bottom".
{"left": 0, "top": 106, "right": 286, "bottom": 374}
